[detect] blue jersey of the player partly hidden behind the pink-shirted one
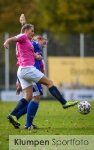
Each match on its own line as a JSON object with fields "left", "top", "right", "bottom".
{"left": 31, "top": 41, "right": 42, "bottom": 70}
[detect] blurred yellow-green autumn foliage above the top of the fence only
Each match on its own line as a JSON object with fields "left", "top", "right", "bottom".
{"left": 0, "top": 0, "right": 94, "bottom": 35}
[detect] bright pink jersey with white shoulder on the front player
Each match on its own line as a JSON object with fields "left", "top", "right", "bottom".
{"left": 16, "top": 34, "right": 35, "bottom": 66}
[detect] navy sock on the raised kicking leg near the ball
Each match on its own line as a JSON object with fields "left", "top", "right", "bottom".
{"left": 49, "top": 86, "right": 67, "bottom": 105}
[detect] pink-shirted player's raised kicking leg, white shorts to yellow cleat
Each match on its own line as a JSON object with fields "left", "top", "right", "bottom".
{"left": 24, "top": 66, "right": 78, "bottom": 108}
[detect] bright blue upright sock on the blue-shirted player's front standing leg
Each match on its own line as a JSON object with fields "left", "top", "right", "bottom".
{"left": 26, "top": 101, "right": 39, "bottom": 127}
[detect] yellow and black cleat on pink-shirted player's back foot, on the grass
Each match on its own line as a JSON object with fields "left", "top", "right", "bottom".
{"left": 7, "top": 115, "right": 20, "bottom": 129}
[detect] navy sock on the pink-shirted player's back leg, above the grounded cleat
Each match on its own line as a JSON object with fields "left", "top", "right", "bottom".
{"left": 11, "top": 98, "right": 28, "bottom": 116}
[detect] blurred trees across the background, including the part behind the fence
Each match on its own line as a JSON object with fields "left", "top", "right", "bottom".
{"left": 0, "top": 0, "right": 94, "bottom": 89}
